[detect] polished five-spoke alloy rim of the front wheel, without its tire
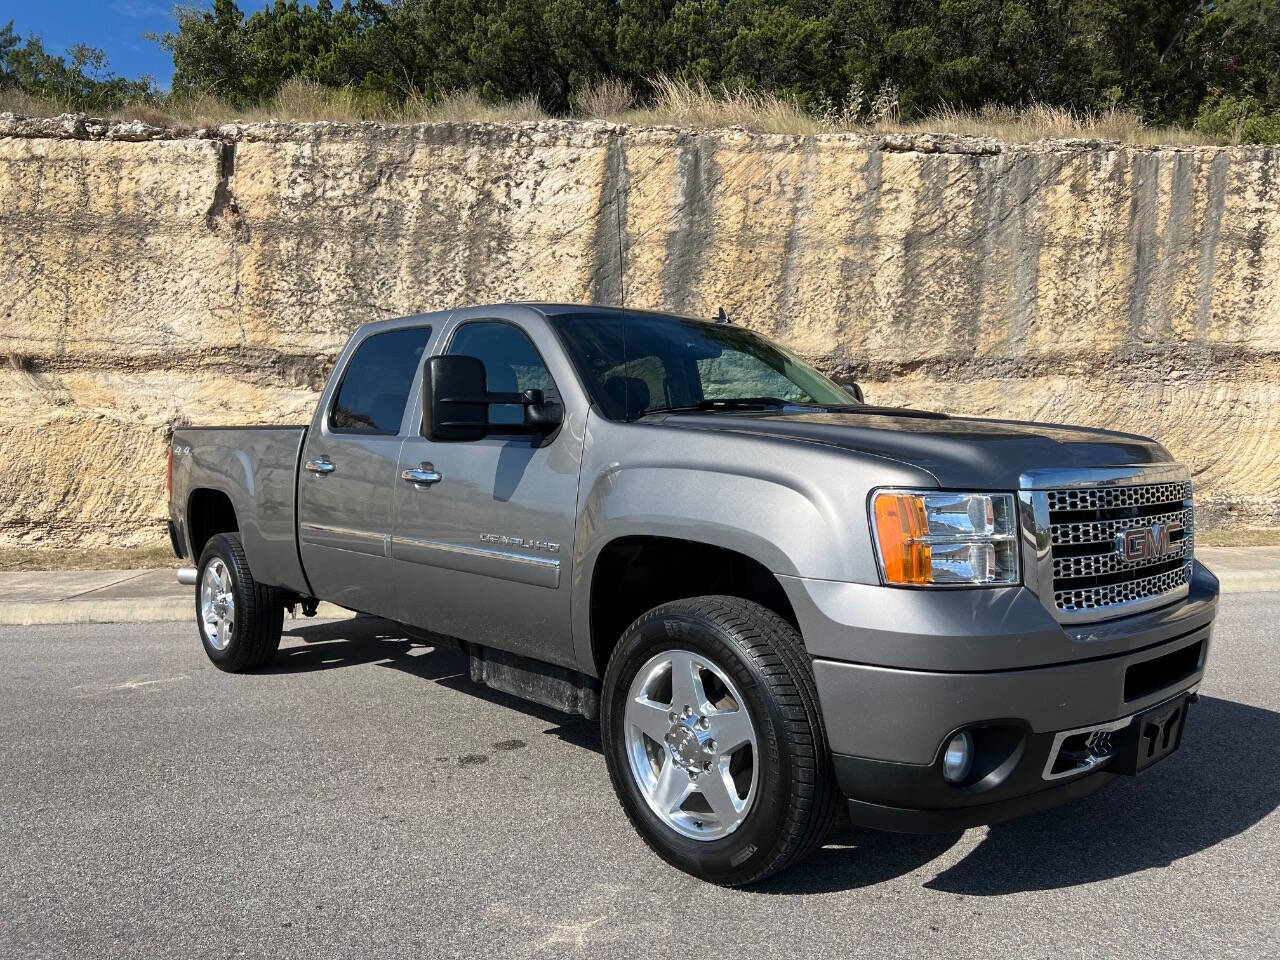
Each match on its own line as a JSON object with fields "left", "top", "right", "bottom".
{"left": 623, "top": 650, "right": 759, "bottom": 840}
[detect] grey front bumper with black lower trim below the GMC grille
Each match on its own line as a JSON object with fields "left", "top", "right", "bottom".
{"left": 788, "top": 564, "right": 1217, "bottom": 832}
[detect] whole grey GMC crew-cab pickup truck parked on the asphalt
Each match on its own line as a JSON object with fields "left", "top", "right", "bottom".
{"left": 169, "top": 303, "right": 1217, "bottom": 884}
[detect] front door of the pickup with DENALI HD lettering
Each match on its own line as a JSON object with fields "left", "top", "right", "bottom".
{"left": 392, "top": 319, "right": 582, "bottom": 664}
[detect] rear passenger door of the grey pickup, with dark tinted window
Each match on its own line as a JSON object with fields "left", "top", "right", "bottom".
{"left": 298, "top": 325, "right": 431, "bottom": 616}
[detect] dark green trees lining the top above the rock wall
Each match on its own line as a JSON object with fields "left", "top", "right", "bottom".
{"left": 10, "top": 0, "right": 1280, "bottom": 137}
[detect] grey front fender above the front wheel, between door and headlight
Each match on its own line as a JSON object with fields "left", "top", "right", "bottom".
{"left": 572, "top": 417, "right": 937, "bottom": 663}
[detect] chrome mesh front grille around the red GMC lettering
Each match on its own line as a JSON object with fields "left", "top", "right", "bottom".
{"left": 1042, "top": 481, "right": 1194, "bottom": 620}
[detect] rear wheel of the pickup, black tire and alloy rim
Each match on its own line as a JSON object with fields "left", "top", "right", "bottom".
{"left": 196, "top": 534, "right": 284, "bottom": 673}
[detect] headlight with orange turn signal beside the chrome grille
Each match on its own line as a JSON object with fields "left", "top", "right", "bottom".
{"left": 872, "top": 490, "right": 1018, "bottom": 586}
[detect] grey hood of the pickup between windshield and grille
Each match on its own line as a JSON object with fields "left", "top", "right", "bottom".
{"left": 655, "top": 407, "right": 1172, "bottom": 490}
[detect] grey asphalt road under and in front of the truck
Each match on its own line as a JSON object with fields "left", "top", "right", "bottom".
{"left": 0, "top": 594, "right": 1280, "bottom": 960}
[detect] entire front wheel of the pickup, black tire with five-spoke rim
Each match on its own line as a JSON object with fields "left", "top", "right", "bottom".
{"left": 600, "top": 596, "right": 837, "bottom": 886}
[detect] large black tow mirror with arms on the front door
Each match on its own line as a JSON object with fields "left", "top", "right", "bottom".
{"left": 422, "top": 353, "right": 563, "bottom": 442}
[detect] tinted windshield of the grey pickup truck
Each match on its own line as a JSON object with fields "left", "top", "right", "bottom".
{"left": 552, "top": 314, "right": 856, "bottom": 420}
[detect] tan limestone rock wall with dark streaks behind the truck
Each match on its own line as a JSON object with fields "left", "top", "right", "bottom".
{"left": 0, "top": 115, "right": 1280, "bottom": 545}
